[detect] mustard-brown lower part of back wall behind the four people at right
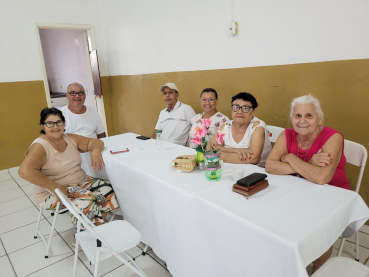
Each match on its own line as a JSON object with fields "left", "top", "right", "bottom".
{"left": 108, "top": 59, "right": 369, "bottom": 203}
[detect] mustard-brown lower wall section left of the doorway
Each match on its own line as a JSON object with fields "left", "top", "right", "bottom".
{"left": 0, "top": 81, "right": 47, "bottom": 170}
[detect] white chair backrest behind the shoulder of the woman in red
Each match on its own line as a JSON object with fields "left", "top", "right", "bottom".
{"left": 343, "top": 139, "right": 368, "bottom": 193}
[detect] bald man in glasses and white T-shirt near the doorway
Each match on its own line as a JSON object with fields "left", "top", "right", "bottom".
{"left": 58, "top": 83, "right": 106, "bottom": 138}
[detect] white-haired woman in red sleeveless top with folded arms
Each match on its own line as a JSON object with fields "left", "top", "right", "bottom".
{"left": 265, "top": 95, "right": 350, "bottom": 272}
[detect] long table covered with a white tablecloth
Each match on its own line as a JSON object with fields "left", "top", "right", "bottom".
{"left": 103, "top": 133, "right": 369, "bottom": 277}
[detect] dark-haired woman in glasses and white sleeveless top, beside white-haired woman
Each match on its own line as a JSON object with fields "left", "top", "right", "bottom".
{"left": 211, "top": 92, "right": 272, "bottom": 167}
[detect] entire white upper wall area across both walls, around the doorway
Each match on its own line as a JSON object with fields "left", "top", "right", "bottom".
{"left": 0, "top": 0, "right": 369, "bottom": 82}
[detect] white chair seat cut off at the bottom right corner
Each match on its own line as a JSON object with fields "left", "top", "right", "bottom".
{"left": 310, "top": 257, "right": 369, "bottom": 277}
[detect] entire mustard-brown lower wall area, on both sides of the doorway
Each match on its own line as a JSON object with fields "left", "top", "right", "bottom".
{"left": 0, "top": 59, "right": 369, "bottom": 203}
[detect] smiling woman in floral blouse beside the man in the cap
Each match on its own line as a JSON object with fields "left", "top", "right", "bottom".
{"left": 188, "top": 88, "right": 229, "bottom": 148}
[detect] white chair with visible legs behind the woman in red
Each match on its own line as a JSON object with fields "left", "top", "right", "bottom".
{"left": 337, "top": 139, "right": 368, "bottom": 261}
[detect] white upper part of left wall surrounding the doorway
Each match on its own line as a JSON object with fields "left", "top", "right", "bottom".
{"left": 0, "top": 0, "right": 108, "bottom": 82}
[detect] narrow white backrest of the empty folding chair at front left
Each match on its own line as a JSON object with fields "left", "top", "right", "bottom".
{"left": 55, "top": 189, "right": 111, "bottom": 248}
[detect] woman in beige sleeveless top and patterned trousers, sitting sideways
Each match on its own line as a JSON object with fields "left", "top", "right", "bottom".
{"left": 18, "top": 108, "right": 119, "bottom": 229}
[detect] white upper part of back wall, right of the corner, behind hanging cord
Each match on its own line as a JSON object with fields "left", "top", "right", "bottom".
{"left": 100, "top": 0, "right": 369, "bottom": 75}
